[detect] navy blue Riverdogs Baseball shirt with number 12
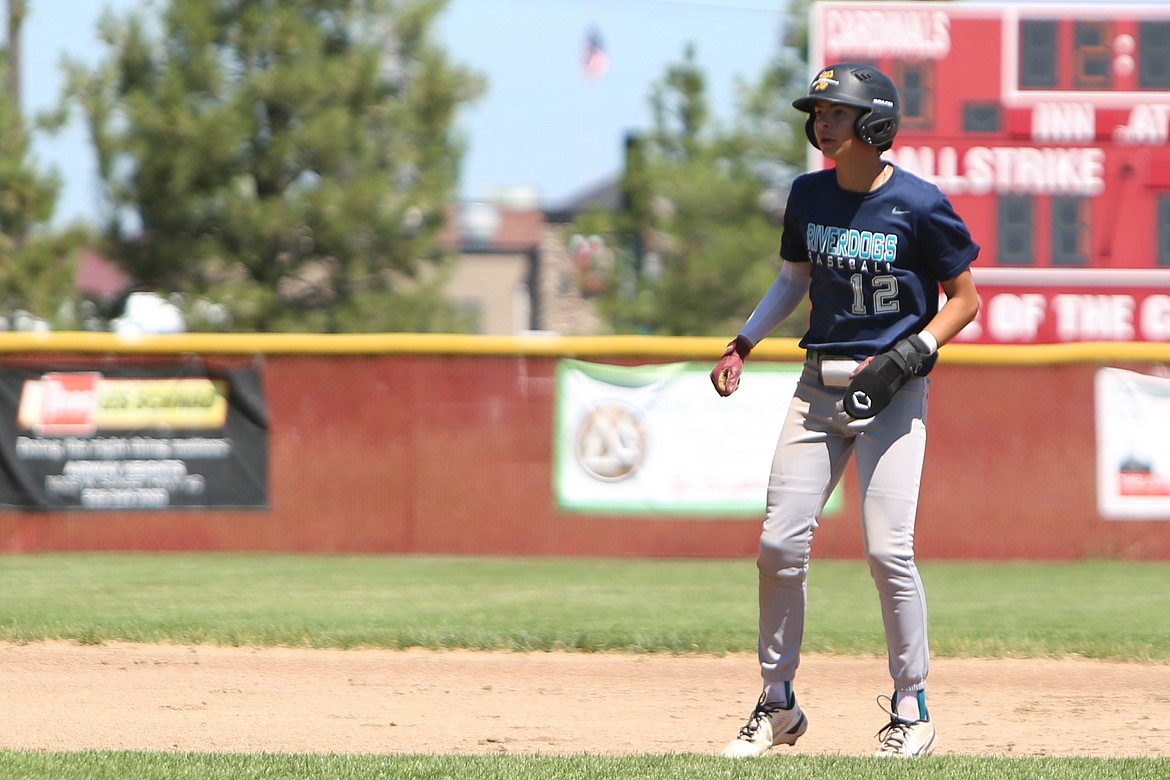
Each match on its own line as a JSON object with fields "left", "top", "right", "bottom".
{"left": 780, "top": 167, "right": 979, "bottom": 359}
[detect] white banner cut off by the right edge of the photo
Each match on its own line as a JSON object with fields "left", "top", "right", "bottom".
{"left": 1094, "top": 368, "right": 1170, "bottom": 520}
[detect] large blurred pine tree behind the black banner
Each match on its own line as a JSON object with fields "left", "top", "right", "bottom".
{"left": 62, "top": 0, "right": 483, "bottom": 332}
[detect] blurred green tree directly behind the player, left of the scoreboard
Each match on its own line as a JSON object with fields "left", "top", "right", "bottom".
{"left": 576, "top": 0, "right": 807, "bottom": 336}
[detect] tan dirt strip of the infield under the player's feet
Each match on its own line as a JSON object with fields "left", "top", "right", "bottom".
{"left": 0, "top": 643, "right": 1170, "bottom": 757}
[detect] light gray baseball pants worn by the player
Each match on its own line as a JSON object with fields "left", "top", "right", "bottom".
{"left": 757, "top": 363, "right": 930, "bottom": 692}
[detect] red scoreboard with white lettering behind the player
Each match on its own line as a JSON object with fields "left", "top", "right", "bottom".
{"left": 810, "top": 1, "right": 1170, "bottom": 344}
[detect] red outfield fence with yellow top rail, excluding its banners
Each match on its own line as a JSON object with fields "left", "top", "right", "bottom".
{"left": 0, "top": 333, "right": 1170, "bottom": 560}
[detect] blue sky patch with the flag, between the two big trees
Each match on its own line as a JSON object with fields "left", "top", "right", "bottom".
{"left": 430, "top": 0, "right": 783, "bottom": 205}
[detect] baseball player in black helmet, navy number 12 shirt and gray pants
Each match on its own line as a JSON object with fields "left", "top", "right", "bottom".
{"left": 711, "top": 62, "right": 979, "bottom": 757}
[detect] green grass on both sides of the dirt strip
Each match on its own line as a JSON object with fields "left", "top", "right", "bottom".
{"left": 0, "top": 553, "right": 1170, "bottom": 780}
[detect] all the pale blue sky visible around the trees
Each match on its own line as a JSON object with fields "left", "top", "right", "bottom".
{"left": 18, "top": 0, "right": 1165, "bottom": 225}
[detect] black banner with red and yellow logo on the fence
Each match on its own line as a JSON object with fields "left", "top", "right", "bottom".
{"left": 0, "top": 360, "right": 268, "bottom": 510}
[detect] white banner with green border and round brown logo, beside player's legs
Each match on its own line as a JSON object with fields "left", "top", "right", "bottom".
{"left": 553, "top": 360, "right": 840, "bottom": 516}
